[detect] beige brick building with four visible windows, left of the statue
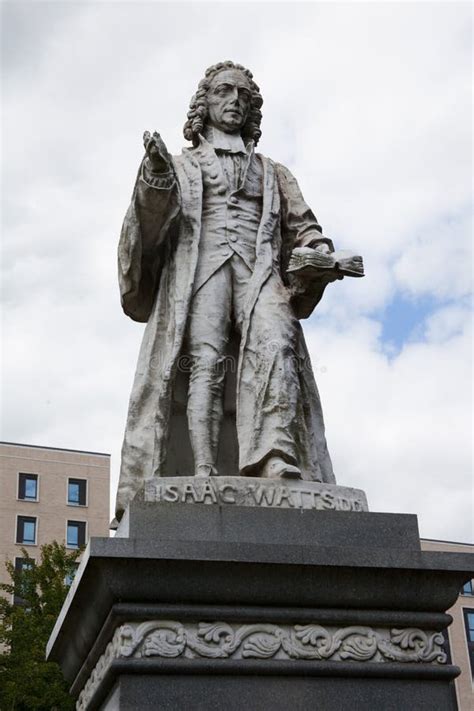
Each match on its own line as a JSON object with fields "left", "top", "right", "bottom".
{"left": 0, "top": 442, "right": 110, "bottom": 582}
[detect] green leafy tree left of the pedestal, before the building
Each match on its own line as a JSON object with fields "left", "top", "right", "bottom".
{"left": 0, "top": 542, "right": 80, "bottom": 711}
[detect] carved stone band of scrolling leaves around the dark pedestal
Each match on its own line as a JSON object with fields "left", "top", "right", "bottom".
{"left": 76, "top": 620, "right": 446, "bottom": 711}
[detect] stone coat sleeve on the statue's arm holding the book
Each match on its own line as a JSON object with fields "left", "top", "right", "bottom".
{"left": 275, "top": 164, "right": 334, "bottom": 252}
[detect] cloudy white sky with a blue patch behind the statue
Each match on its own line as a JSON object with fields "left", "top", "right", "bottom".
{"left": 1, "top": 0, "right": 473, "bottom": 541}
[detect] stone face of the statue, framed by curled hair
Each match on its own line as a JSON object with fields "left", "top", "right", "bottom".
{"left": 207, "top": 69, "right": 251, "bottom": 133}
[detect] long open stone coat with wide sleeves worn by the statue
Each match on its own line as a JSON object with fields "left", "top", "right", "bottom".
{"left": 117, "top": 149, "right": 335, "bottom": 516}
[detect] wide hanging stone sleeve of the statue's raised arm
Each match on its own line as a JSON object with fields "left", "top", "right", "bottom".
{"left": 118, "top": 160, "right": 180, "bottom": 322}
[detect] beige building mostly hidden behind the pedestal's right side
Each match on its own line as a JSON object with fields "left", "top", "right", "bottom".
{"left": 421, "top": 538, "right": 474, "bottom": 711}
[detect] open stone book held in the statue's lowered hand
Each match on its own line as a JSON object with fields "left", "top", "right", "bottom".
{"left": 287, "top": 247, "right": 364, "bottom": 279}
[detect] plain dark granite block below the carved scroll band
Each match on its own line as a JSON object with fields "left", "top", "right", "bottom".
{"left": 101, "top": 671, "right": 456, "bottom": 711}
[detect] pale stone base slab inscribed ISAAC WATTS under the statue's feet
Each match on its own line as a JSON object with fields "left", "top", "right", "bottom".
{"left": 138, "top": 476, "right": 368, "bottom": 511}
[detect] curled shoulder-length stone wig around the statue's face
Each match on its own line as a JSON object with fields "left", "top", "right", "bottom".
{"left": 183, "top": 60, "right": 263, "bottom": 145}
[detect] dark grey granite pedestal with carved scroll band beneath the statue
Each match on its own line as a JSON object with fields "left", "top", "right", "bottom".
{"left": 48, "top": 501, "right": 472, "bottom": 711}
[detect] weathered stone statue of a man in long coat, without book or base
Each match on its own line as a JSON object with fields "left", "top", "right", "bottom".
{"left": 117, "top": 61, "right": 334, "bottom": 518}
